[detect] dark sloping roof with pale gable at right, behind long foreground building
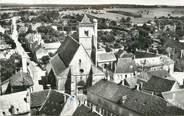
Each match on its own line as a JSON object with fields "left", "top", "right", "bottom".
{"left": 138, "top": 76, "right": 175, "bottom": 92}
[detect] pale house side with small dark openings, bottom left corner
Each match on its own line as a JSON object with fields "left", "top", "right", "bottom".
{"left": 0, "top": 91, "right": 30, "bottom": 116}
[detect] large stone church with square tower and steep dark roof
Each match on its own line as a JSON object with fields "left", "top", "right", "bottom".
{"left": 47, "top": 15, "right": 105, "bottom": 95}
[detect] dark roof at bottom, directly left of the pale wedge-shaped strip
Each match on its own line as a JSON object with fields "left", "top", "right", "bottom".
{"left": 40, "top": 90, "right": 65, "bottom": 116}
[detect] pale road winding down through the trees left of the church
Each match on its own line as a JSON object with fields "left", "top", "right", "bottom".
{"left": 12, "top": 17, "right": 45, "bottom": 91}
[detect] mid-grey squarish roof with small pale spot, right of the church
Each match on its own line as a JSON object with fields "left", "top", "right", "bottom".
{"left": 115, "top": 58, "right": 136, "bottom": 73}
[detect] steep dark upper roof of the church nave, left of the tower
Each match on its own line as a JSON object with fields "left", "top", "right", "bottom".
{"left": 57, "top": 36, "right": 80, "bottom": 66}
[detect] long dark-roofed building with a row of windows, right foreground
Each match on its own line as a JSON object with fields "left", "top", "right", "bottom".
{"left": 87, "top": 80, "right": 184, "bottom": 116}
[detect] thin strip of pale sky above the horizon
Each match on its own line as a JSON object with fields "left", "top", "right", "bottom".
{"left": 0, "top": 0, "right": 184, "bottom": 6}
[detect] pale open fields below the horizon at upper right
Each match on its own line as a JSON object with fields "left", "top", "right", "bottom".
{"left": 106, "top": 8, "right": 184, "bottom": 23}
